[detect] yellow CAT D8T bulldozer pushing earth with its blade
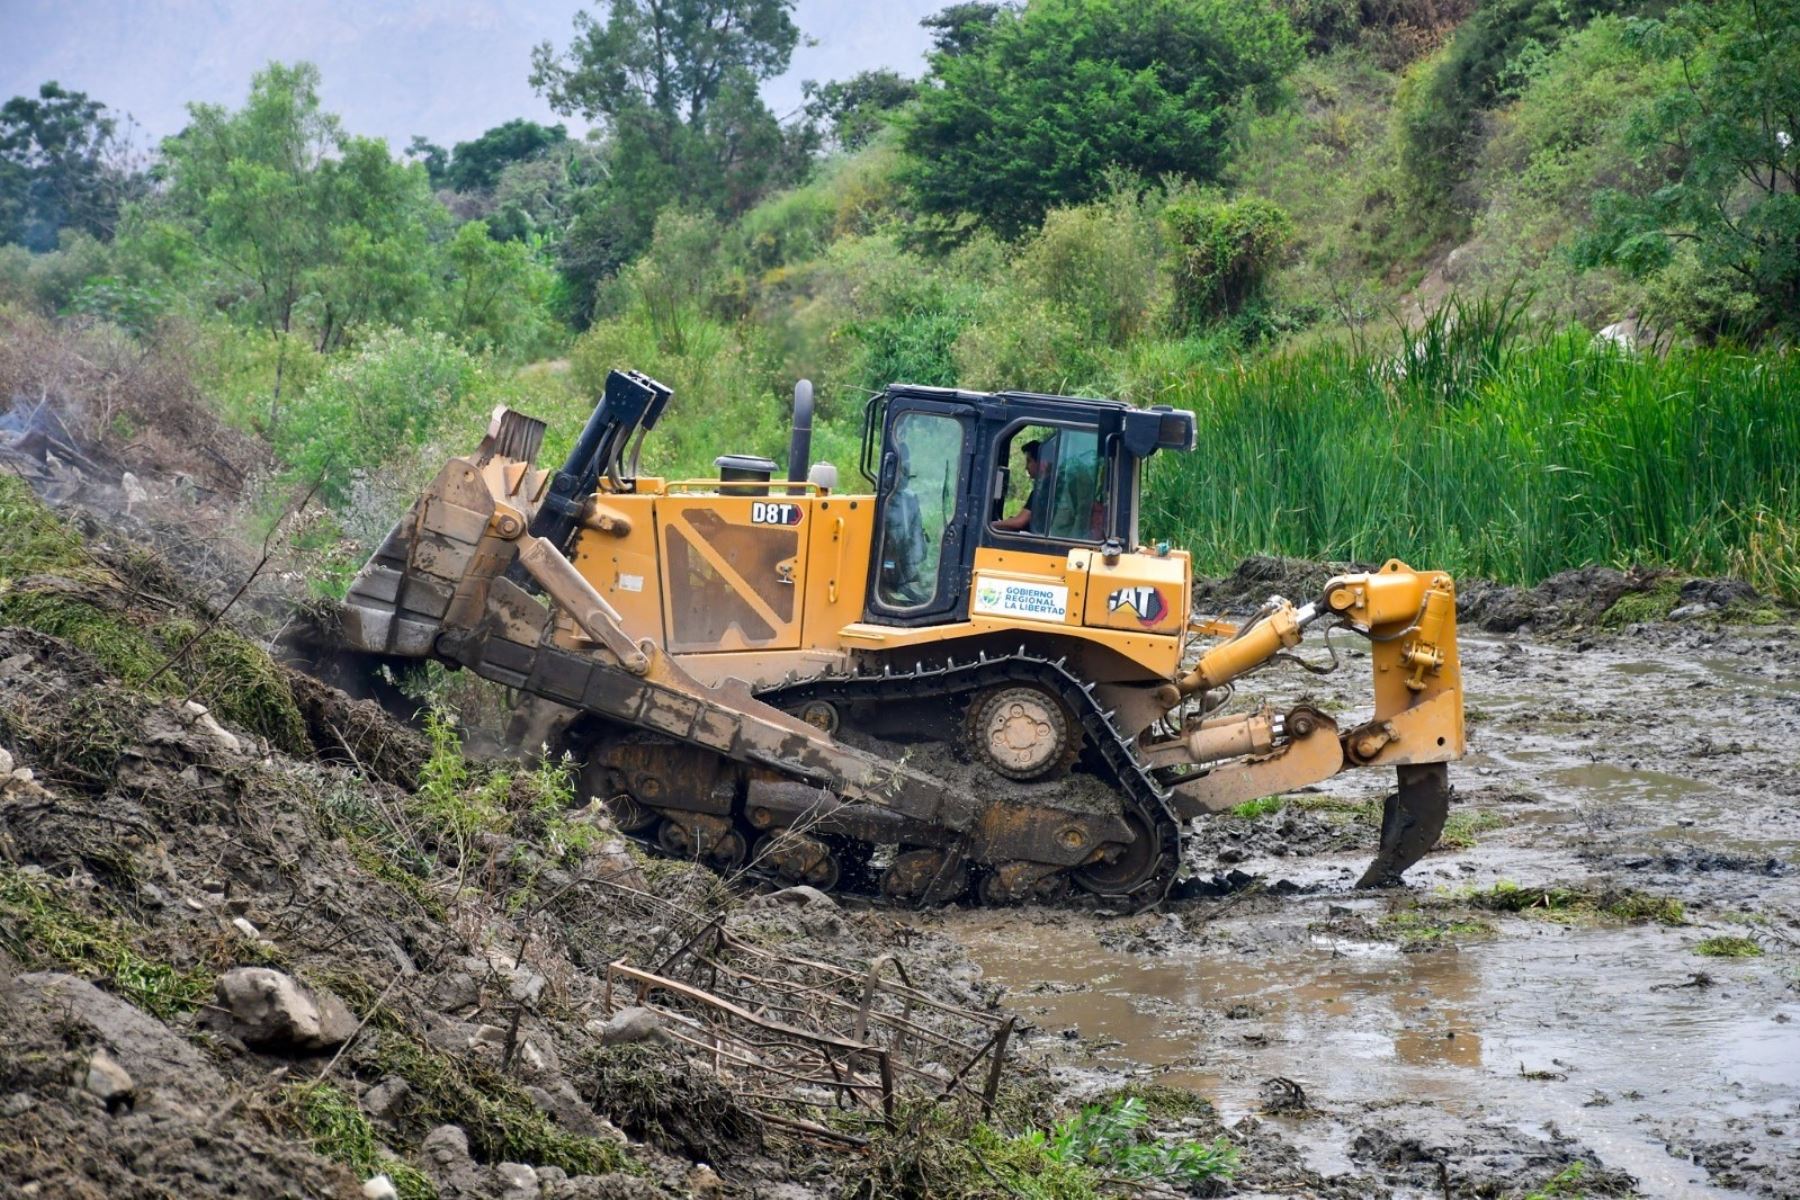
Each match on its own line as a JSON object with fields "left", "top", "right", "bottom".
{"left": 340, "top": 371, "right": 1463, "bottom": 910}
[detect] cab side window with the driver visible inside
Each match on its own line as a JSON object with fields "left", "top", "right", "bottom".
{"left": 990, "top": 425, "right": 1112, "bottom": 542}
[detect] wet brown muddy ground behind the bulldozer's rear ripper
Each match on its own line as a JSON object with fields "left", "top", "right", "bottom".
{"left": 932, "top": 618, "right": 1800, "bottom": 1196}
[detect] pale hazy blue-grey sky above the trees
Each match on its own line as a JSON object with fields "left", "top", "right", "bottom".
{"left": 0, "top": 0, "right": 949, "bottom": 149}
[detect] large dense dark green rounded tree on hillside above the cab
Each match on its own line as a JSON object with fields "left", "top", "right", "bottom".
{"left": 900, "top": 0, "right": 1300, "bottom": 236}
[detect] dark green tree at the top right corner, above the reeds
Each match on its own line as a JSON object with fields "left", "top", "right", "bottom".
{"left": 1579, "top": 0, "right": 1800, "bottom": 333}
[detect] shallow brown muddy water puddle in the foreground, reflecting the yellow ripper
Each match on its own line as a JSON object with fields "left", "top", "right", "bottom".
{"left": 950, "top": 901, "right": 1800, "bottom": 1196}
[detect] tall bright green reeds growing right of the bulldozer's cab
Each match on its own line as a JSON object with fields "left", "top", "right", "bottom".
{"left": 1145, "top": 331, "right": 1800, "bottom": 603}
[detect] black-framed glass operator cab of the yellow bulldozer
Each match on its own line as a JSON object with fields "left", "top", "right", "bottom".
{"left": 862, "top": 385, "right": 1193, "bottom": 626}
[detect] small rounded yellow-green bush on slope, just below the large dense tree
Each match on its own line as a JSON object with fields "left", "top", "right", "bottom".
{"left": 1166, "top": 196, "right": 1294, "bottom": 329}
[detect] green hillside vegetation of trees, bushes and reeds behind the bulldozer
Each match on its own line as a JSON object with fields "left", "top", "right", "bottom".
{"left": 0, "top": 0, "right": 1800, "bottom": 597}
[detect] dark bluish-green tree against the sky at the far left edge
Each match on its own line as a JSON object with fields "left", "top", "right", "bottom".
{"left": 0, "top": 79, "right": 142, "bottom": 250}
